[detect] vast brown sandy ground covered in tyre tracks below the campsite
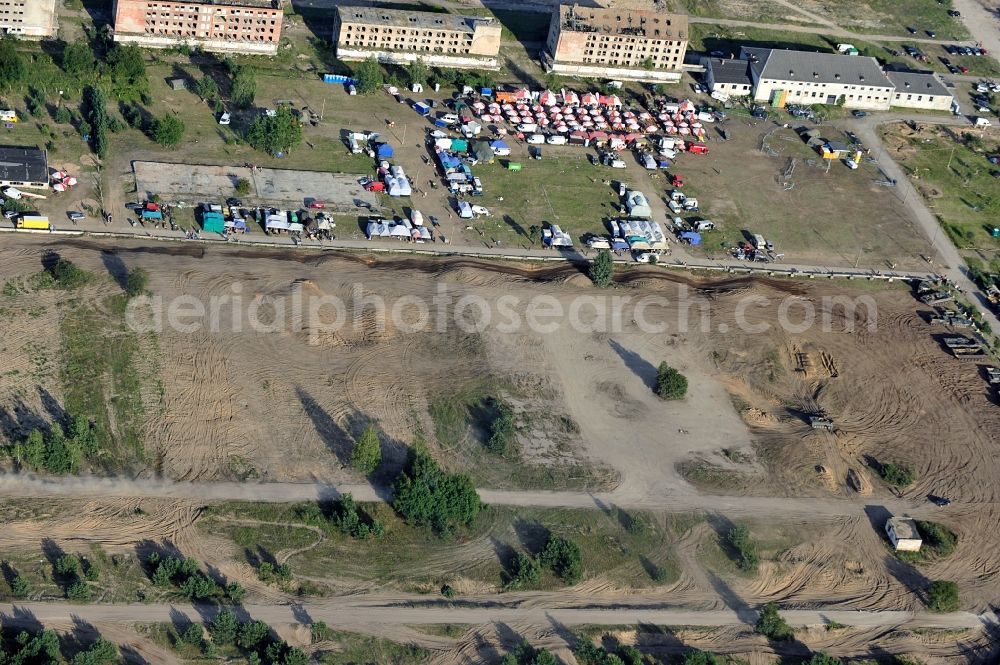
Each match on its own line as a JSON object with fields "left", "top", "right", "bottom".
{"left": 0, "top": 238, "right": 1000, "bottom": 660}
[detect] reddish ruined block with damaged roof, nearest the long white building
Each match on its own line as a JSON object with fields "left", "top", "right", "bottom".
{"left": 543, "top": 5, "right": 688, "bottom": 81}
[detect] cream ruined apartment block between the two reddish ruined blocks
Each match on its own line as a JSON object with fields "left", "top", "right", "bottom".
{"left": 333, "top": 7, "right": 501, "bottom": 69}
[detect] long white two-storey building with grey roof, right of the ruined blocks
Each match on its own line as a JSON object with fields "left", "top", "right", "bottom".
{"left": 740, "top": 47, "right": 895, "bottom": 111}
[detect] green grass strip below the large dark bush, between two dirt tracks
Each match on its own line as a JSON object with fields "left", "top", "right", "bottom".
{"left": 199, "top": 502, "right": 689, "bottom": 593}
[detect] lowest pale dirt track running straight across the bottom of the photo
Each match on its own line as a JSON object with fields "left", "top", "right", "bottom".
{"left": 0, "top": 594, "right": 984, "bottom": 632}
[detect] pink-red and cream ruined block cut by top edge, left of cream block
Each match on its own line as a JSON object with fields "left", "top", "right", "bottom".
{"left": 114, "top": 0, "right": 284, "bottom": 55}
